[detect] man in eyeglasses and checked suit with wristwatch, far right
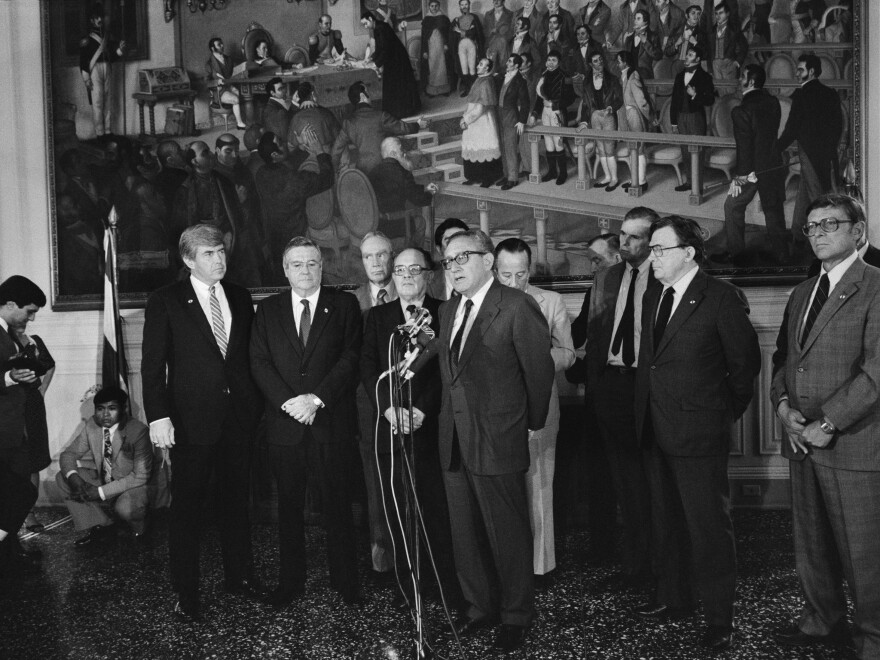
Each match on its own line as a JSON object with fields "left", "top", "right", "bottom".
{"left": 770, "top": 194, "right": 880, "bottom": 658}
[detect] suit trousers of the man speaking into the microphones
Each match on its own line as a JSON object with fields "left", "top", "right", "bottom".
{"left": 443, "top": 439, "right": 535, "bottom": 626}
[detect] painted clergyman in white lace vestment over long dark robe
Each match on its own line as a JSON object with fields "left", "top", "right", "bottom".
{"left": 461, "top": 57, "right": 503, "bottom": 188}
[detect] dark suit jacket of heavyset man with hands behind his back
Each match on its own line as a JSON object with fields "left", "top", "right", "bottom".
{"left": 635, "top": 271, "right": 761, "bottom": 456}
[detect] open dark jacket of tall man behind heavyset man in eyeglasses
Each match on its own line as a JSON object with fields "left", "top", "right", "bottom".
{"left": 584, "top": 261, "right": 663, "bottom": 395}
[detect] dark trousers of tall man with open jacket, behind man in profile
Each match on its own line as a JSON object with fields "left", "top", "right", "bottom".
{"left": 593, "top": 366, "right": 651, "bottom": 577}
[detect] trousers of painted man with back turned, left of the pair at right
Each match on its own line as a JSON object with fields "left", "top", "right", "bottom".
{"left": 724, "top": 169, "right": 787, "bottom": 255}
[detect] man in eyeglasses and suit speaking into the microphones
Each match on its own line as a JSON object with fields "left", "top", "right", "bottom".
{"left": 437, "top": 230, "right": 554, "bottom": 651}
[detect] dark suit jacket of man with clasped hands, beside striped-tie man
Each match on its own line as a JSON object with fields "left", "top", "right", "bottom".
{"left": 251, "top": 286, "right": 361, "bottom": 445}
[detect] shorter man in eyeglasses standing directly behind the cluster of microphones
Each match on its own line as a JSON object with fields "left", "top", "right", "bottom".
{"left": 361, "top": 248, "right": 461, "bottom": 605}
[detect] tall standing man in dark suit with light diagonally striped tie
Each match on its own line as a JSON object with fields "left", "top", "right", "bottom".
{"left": 141, "top": 224, "right": 262, "bottom": 620}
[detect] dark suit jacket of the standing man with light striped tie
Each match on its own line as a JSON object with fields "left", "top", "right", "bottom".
{"left": 141, "top": 277, "right": 263, "bottom": 446}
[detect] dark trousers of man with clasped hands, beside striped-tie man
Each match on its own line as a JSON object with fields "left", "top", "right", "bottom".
{"left": 269, "top": 434, "right": 359, "bottom": 596}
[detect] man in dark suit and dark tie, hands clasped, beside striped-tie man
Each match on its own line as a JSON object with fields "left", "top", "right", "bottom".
{"left": 251, "top": 236, "right": 362, "bottom": 607}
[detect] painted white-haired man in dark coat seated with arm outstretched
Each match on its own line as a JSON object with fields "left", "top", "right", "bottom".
{"left": 369, "top": 137, "right": 438, "bottom": 247}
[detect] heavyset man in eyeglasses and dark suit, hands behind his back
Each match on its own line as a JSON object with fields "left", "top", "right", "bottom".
{"left": 635, "top": 215, "right": 761, "bottom": 652}
